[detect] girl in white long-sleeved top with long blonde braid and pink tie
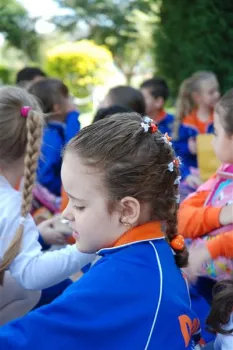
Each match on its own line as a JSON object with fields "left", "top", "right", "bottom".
{"left": 0, "top": 87, "right": 93, "bottom": 324}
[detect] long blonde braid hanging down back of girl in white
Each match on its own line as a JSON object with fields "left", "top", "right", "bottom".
{"left": 0, "top": 110, "right": 43, "bottom": 285}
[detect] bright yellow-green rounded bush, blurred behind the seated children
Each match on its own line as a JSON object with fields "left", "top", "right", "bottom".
{"left": 46, "top": 40, "right": 113, "bottom": 97}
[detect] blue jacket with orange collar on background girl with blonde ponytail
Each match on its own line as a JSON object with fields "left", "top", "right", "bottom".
{"left": 173, "top": 111, "right": 214, "bottom": 178}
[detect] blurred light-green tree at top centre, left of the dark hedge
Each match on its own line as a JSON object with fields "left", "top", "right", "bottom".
{"left": 54, "top": 0, "right": 153, "bottom": 82}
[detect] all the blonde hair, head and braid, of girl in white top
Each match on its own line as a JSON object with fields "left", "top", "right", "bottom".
{"left": 0, "top": 87, "right": 43, "bottom": 284}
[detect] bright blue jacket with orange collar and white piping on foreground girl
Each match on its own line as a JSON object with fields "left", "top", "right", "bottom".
{"left": 0, "top": 223, "right": 199, "bottom": 350}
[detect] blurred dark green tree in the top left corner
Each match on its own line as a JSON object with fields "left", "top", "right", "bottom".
{"left": 0, "top": 0, "right": 39, "bottom": 61}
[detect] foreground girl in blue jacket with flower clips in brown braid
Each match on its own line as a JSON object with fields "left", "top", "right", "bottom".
{"left": 0, "top": 113, "right": 199, "bottom": 350}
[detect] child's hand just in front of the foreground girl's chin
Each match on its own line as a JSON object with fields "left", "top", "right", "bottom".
{"left": 37, "top": 217, "right": 66, "bottom": 245}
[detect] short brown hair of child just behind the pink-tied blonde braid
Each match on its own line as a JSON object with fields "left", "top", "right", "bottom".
{"left": 28, "top": 78, "right": 69, "bottom": 114}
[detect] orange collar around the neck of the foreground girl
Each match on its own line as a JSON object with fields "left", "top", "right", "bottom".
{"left": 113, "top": 221, "right": 164, "bottom": 248}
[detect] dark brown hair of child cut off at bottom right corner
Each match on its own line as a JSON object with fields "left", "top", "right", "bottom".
{"left": 206, "top": 280, "right": 233, "bottom": 334}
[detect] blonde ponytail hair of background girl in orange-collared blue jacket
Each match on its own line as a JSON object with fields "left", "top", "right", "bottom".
{"left": 173, "top": 71, "right": 216, "bottom": 138}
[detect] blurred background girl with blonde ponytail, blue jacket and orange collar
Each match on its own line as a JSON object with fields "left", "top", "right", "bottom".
{"left": 174, "top": 72, "right": 220, "bottom": 188}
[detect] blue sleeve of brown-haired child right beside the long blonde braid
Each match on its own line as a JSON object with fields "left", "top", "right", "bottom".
{"left": 37, "top": 129, "right": 63, "bottom": 196}
